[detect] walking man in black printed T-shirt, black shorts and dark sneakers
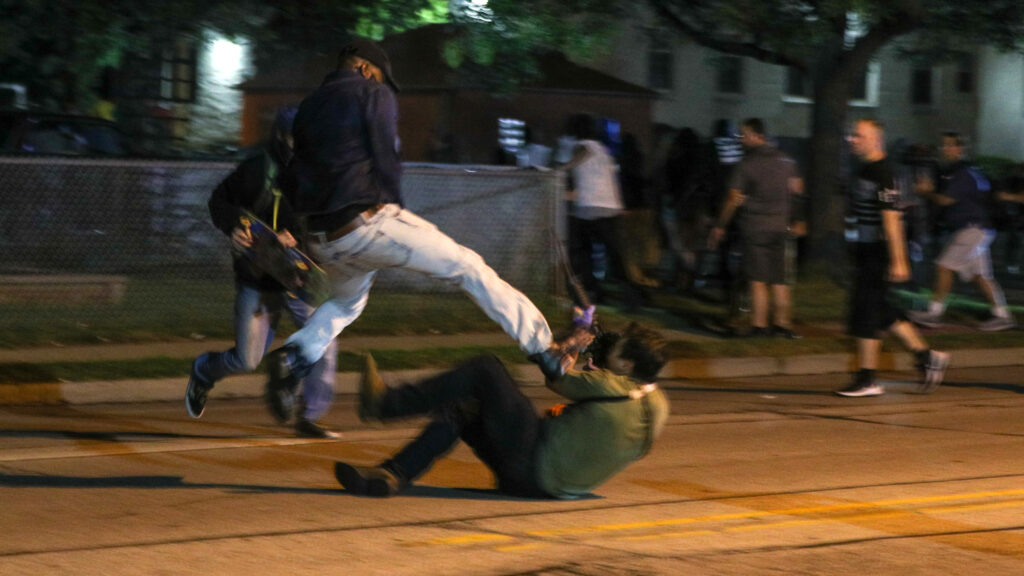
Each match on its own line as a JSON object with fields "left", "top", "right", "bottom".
{"left": 836, "top": 119, "right": 949, "bottom": 397}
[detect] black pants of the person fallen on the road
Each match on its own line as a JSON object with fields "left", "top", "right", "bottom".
{"left": 381, "top": 356, "right": 547, "bottom": 497}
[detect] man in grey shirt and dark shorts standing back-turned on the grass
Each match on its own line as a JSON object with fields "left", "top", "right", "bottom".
{"left": 709, "top": 118, "right": 804, "bottom": 338}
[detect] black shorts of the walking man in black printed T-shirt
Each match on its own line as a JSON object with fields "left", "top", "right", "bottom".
{"left": 848, "top": 242, "right": 903, "bottom": 339}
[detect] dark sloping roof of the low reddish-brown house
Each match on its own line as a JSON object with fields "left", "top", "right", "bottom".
{"left": 238, "top": 25, "right": 657, "bottom": 97}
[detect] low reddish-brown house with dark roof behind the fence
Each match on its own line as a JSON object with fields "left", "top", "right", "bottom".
{"left": 239, "top": 25, "right": 658, "bottom": 164}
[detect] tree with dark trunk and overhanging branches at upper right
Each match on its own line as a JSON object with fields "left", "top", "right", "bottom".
{"left": 647, "top": 0, "right": 1024, "bottom": 255}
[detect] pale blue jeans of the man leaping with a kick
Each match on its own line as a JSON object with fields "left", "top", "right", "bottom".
{"left": 287, "top": 204, "right": 552, "bottom": 364}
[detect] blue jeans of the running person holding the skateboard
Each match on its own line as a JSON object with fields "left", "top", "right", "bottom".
{"left": 196, "top": 283, "right": 338, "bottom": 421}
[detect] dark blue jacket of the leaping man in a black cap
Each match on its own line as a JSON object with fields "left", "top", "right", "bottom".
{"left": 284, "top": 70, "right": 401, "bottom": 215}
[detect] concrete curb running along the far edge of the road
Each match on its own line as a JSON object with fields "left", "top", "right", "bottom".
{"left": 0, "top": 348, "right": 1024, "bottom": 406}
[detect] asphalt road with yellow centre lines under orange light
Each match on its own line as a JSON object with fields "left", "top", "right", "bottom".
{"left": 0, "top": 367, "right": 1024, "bottom": 576}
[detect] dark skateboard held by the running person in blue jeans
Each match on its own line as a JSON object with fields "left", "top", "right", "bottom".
{"left": 241, "top": 212, "right": 330, "bottom": 306}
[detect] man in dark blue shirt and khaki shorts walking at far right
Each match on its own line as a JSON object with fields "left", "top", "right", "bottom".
{"left": 907, "top": 132, "right": 1017, "bottom": 331}
